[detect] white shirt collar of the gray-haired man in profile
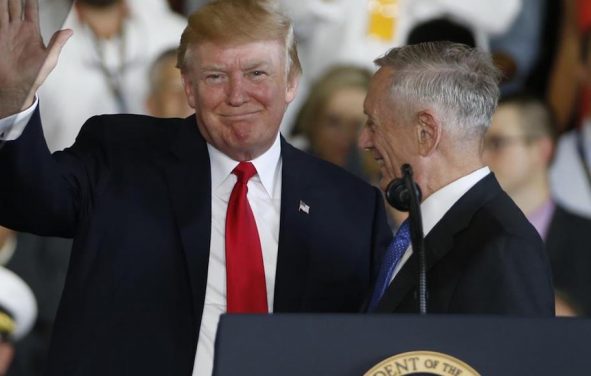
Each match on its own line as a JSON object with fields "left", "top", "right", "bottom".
{"left": 421, "top": 166, "right": 490, "bottom": 235}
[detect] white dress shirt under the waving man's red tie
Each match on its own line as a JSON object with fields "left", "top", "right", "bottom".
{"left": 193, "top": 136, "right": 282, "bottom": 376}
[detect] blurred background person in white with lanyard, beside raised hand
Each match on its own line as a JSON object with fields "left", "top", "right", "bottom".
{"left": 38, "top": 0, "right": 186, "bottom": 151}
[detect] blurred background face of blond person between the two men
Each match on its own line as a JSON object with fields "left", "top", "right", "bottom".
{"left": 310, "top": 87, "right": 366, "bottom": 166}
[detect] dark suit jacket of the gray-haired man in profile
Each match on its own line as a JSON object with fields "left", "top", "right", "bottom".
{"left": 377, "top": 173, "right": 554, "bottom": 316}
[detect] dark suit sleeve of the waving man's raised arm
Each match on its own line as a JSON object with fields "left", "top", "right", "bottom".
{"left": 0, "top": 109, "right": 99, "bottom": 237}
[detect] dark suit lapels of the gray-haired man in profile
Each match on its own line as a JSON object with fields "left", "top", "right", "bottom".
{"left": 376, "top": 173, "right": 501, "bottom": 312}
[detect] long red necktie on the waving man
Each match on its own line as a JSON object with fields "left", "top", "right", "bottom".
{"left": 226, "top": 162, "right": 269, "bottom": 313}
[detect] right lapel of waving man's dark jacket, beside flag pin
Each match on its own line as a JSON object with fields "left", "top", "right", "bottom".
{"left": 273, "top": 137, "right": 314, "bottom": 312}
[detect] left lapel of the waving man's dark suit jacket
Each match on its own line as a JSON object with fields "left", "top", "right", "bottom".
{"left": 164, "top": 116, "right": 211, "bottom": 328}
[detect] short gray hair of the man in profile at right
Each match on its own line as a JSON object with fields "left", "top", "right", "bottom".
{"left": 374, "top": 42, "right": 500, "bottom": 138}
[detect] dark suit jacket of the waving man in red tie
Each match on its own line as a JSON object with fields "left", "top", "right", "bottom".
{"left": 0, "top": 107, "right": 391, "bottom": 376}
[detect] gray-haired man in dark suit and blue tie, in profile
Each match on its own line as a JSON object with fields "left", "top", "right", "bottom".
{"left": 359, "top": 42, "right": 554, "bottom": 316}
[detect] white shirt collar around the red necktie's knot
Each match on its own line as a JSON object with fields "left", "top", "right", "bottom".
{"left": 207, "top": 133, "right": 281, "bottom": 197}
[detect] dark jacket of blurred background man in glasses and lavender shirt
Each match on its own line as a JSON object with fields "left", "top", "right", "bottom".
{"left": 546, "top": 206, "right": 591, "bottom": 315}
